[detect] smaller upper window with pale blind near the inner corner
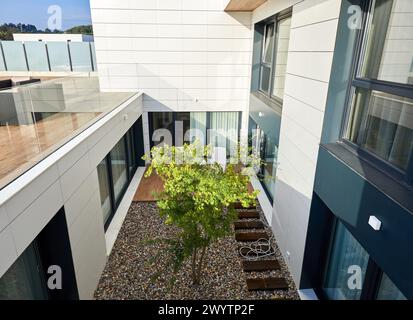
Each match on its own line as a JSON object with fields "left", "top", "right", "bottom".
{"left": 259, "top": 11, "right": 291, "bottom": 102}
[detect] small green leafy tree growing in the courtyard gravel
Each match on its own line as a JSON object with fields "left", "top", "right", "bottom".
{"left": 144, "top": 142, "right": 259, "bottom": 284}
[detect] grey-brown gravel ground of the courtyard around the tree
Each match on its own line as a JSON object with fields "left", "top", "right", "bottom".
{"left": 95, "top": 202, "right": 298, "bottom": 300}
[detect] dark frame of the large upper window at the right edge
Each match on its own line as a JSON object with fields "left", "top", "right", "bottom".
{"left": 340, "top": 0, "right": 413, "bottom": 188}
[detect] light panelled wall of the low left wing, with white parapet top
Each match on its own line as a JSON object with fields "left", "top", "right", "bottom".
{"left": 0, "top": 94, "right": 142, "bottom": 299}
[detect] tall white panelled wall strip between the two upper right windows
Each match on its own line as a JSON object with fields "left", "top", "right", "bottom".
{"left": 253, "top": 0, "right": 341, "bottom": 284}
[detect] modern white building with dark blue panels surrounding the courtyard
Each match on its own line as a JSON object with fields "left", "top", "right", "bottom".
{"left": 0, "top": 0, "right": 413, "bottom": 300}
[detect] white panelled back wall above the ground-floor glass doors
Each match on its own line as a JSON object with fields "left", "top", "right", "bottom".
{"left": 90, "top": 0, "right": 252, "bottom": 115}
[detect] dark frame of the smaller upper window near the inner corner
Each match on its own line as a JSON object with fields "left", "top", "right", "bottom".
{"left": 255, "top": 8, "right": 292, "bottom": 108}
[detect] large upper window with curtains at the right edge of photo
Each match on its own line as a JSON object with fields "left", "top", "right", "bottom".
{"left": 345, "top": 0, "right": 413, "bottom": 183}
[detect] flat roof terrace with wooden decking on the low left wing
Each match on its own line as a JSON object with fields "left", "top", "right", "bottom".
{"left": 0, "top": 76, "right": 136, "bottom": 190}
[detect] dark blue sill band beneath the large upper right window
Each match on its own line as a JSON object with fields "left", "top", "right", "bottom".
{"left": 320, "top": 142, "right": 413, "bottom": 212}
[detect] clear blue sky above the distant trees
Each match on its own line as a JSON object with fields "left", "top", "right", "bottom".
{"left": 0, "top": 0, "right": 91, "bottom": 30}
